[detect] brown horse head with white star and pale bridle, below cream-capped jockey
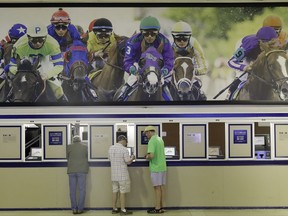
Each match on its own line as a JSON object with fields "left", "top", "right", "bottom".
{"left": 173, "top": 52, "right": 195, "bottom": 100}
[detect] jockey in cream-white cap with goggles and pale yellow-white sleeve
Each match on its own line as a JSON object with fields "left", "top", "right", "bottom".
{"left": 171, "top": 21, "right": 208, "bottom": 100}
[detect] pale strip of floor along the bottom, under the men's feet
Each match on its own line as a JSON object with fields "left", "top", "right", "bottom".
{"left": 0, "top": 209, "right": 288, "bottom": 216}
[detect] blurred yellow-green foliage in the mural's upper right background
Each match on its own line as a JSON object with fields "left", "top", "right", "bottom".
{"left": 163, "top": 6, "right": 288, "bottom": 70}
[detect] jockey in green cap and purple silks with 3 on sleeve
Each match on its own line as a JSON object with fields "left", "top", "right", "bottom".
{"left": 117, "top": 16, "right": 174, "bottom": 101}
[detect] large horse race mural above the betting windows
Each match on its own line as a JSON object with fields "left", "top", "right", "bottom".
{"left": 0, "top": 2, "right": 288, "bottom": 106}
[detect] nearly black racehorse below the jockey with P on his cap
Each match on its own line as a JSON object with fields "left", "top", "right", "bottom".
{"left": 8, "top": 58, "right": 56, "bottom": 102}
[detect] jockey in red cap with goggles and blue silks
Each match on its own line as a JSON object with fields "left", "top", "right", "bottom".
{"left": 47, "top": 8, "right": 81, "bottom": 53}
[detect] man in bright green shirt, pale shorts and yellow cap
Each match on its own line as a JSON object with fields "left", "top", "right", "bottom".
{"left": 144, "top": 126, "right": 167, "bottom": 214}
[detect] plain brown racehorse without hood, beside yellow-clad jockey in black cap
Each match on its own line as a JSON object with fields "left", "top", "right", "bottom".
{"left": 90, "top": 36, "right": 128, "bottom": 101}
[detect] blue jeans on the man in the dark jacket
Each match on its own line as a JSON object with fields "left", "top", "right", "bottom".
{"left": 68, "top": 173, "right": 87, "bottom": 211}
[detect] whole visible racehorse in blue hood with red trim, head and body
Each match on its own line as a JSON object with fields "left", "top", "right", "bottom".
{"left": 62, "top": 40, "right": 101, "bottom": 103}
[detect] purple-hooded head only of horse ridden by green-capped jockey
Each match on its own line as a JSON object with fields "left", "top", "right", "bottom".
{"left": 138, "top": 47, "right": 164, "bottom": 95}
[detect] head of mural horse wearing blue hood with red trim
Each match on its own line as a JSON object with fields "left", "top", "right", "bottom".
{"left": 64, "top": 40, "right": 89, "bottom": 91}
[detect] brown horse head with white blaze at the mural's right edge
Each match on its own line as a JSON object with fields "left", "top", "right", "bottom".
{"left": 251, "top": 43, "right": 288, "bottom": 101}
